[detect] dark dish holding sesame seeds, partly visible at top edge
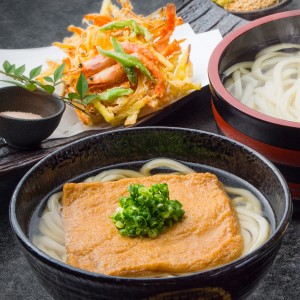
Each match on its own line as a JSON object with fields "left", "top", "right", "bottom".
{"left": 225, "top": 0, "right": 292, "bottom": 21}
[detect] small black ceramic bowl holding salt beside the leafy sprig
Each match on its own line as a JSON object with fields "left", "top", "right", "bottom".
{"left": 0, "top": 86, "right": 65, "bottom": 149}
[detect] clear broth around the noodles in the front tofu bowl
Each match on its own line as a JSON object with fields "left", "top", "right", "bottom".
{"left": 29, "top": 161, "right": 276, "bottom": 274}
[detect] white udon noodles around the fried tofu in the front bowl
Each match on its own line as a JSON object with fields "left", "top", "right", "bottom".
{"left": 33, "top": 158, "right": 270, "bottom": 270}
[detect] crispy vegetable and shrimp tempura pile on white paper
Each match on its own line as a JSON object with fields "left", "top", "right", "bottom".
{"left": 42, "top": 0, "right": 200, "bottom": 126}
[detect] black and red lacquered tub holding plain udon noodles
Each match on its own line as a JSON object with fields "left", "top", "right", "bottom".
{"left": 208, "top": 10, "right": 300, "bottom": 203}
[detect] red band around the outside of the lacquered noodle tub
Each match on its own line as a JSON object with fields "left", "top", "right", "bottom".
{"left": 212, "top": 102, "right": 300, "bottom": 167}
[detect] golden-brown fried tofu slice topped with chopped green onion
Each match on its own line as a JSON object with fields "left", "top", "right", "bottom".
{"left": 62, "top": 173, "right": 244, "bottom": 277}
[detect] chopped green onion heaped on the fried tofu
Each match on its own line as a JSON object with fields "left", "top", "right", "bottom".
{"left": 111, "top": 183, "right": 185, "bottom": 238}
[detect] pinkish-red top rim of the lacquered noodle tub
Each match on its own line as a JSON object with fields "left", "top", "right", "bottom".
{"left": 208, "top": 10, "right": 300, "bottom": 129}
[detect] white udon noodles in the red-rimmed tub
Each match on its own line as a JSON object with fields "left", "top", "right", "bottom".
{"left": 224, "top": 44, "right": 300, "bottom": 122}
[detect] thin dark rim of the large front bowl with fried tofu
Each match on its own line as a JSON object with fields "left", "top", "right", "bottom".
{"left": 9, "top": 126, "right": 293, "bottom": 285}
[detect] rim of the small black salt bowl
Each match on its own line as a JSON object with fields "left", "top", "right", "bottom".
{"left": 0, "top": 86, "right": 66, "bottom": 123}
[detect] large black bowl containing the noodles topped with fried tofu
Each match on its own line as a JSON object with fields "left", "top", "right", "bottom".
{"left": 10, "top": 127, "right": 292, "bottom": 300}
